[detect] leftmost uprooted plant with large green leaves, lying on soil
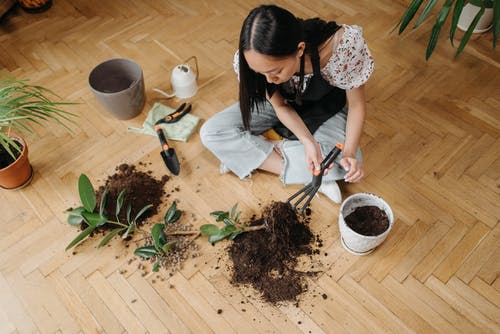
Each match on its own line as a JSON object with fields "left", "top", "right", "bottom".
{"left": 65, "top": 174, "right": 152, "bottom": 250}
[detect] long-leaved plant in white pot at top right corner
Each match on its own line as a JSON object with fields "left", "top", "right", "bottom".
{"left": 396, "top": 0, "right": 500, "bottom": 60}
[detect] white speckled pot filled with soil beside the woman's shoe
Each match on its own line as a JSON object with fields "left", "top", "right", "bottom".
{"left": 339, "top": 193, "right": 394, "bottom": 255}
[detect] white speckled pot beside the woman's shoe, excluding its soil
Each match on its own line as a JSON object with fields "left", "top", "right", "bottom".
{"left": 339, "top": 193, "right": 394, "bottom": 255}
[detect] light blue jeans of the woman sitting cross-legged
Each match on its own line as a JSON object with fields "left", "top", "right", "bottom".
{"left": 200, "top": 103, "right": 361, "bottom": 184}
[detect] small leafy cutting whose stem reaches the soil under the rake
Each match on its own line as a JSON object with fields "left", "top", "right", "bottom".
{"left": 200, "top": 203, "right": 266, "bottom": 243}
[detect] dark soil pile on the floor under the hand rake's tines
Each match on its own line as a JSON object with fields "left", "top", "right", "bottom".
{"left": 229, "top": 202, "right": 314, "bottom": 304}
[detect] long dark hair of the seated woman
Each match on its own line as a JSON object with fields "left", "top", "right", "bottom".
{"left": 239, "top": 5, "right": 337, "bottom": 129}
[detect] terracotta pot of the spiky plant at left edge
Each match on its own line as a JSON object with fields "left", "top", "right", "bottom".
{"left": 0, "top": 136, "right": 33, "bottom": 189}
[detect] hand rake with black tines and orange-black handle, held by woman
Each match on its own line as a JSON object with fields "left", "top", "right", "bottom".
{"left": 287, "top": 143, "right": 344, "bottom": 216}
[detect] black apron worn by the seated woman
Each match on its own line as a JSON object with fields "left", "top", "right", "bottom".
{"left": 273, "top": 38, "right": 346, "bottom": 140}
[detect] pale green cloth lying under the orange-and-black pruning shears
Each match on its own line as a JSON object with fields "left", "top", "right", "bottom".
{"left": 128, "top": 102, "right": 200, "bottom": 142}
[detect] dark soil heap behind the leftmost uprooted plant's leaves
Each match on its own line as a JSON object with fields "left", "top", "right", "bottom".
{"left": 96, "top": 164, "right": 169, "bottom": 227}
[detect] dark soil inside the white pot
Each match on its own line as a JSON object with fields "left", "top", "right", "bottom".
{"left": 345, "top": 205, "right": 389, "bottom": 236}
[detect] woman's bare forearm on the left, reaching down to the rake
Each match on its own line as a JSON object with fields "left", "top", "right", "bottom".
{"left": 269, "top": 91, "right": 322, "bottom": 173}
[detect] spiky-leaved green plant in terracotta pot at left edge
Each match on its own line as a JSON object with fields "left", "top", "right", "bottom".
{"left": 0, "top": 79, "right": 76, "bottom": 189}
